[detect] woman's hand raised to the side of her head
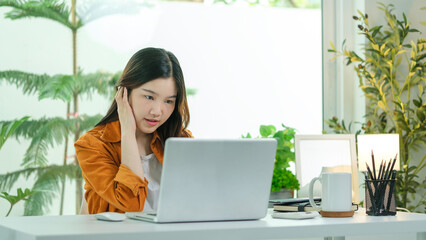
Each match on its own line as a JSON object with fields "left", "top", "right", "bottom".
{"left": 115, "top": 87, "right": 136, "bottom": 135}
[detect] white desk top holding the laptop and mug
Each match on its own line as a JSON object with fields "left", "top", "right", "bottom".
{"left": 0, "top": 209, "right": 426, "bottom": 240}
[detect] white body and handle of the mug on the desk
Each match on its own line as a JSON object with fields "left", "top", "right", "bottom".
{"left": 309, "top": 172, "right": 352, "bottom": 212}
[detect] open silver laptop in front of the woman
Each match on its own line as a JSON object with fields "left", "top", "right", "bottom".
{"left": 126, "top": 138, "right": 277, "bottom": 223}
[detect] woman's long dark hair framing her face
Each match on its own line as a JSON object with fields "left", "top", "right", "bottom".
{"left": 96, "top": 48, "right": 189, "bottom": 143}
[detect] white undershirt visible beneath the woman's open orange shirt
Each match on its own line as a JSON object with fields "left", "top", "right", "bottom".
{"left": 141, "top": 153, "right": 162, "bottom": 213}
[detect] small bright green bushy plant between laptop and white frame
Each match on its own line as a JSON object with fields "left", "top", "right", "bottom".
{"left": 242, "top": 124, "right": 300, "bottom": 199}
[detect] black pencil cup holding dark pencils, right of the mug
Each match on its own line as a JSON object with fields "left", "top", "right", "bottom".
{"left": 365, "top": 179, "right": 396, "bottom": 216}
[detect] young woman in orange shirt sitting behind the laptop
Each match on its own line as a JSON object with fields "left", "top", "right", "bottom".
{"left": 74, "top": 48, "right": 192, "bottom": 214}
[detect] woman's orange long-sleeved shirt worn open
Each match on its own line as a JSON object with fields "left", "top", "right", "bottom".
{"left": 74, "top": 121, "right": 192, "bottom": 214}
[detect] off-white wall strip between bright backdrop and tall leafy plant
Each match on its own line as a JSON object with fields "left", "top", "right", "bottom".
{"left": 322, "top": 0, "right": 365, "bottom": 129}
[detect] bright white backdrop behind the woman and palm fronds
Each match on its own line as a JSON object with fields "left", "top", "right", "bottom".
{"left": 0, "top": 2, "right": 322, "bottom": 216}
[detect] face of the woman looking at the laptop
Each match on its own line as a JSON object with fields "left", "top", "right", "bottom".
{"left": 129, "top": 77, "right": 177, "bottom": 134}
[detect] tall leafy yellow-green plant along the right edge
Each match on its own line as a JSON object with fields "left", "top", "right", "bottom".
{"left": 327, "top": 3, "right": 426, "bottom": 211}
